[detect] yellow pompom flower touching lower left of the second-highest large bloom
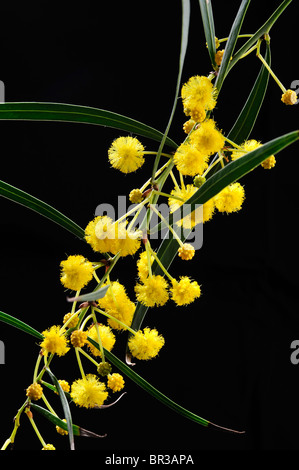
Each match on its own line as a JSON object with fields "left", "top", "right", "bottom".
{"left": 173, "top": 143, "right": 209, "bottom": 176}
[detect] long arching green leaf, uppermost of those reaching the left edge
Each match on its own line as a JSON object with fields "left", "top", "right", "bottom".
{"left": 0, "top": 102, "right": 177, "bottom": 148}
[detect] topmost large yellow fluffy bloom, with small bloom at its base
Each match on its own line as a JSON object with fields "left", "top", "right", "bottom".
{"left": 181, "top": 75, "right": 216, "bottom": 122}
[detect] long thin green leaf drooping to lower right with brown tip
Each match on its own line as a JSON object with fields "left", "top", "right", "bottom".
{"left": 88, "top": 337, "right": 244, "bottom": 433}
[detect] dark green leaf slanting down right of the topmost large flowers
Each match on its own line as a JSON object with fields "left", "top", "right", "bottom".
{"left": 227, "top": 42, "right": 271, "bottom": 145}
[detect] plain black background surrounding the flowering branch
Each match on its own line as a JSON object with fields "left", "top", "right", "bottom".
{"left": 0, "top": 0, "right": 299, "bottom": 454}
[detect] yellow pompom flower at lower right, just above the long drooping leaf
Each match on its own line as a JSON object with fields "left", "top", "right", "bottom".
{"left": 128, "top": 328, "right": 165, "bottom": 360}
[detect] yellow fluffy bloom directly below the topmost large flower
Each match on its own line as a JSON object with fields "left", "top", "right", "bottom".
{"left": 190, "top": 119, "right": 225, "bottom": 156}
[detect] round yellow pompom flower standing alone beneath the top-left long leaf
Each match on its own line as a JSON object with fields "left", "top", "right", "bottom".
{"left": 108, "top": 136, "right": 144, "bottom": 173}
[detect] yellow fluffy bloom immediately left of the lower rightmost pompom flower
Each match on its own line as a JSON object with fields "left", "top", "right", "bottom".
{"left": 135, "top": 275, "right": 169, "bottom": 307}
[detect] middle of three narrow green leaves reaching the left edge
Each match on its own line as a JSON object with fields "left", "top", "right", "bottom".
{"left": 0, "top": 179, "right": 84, "bottom": 238}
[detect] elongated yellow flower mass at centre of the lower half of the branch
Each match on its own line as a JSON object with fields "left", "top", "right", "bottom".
{"left": 98, "top": 281, "right": 135, "bottom": 330}
